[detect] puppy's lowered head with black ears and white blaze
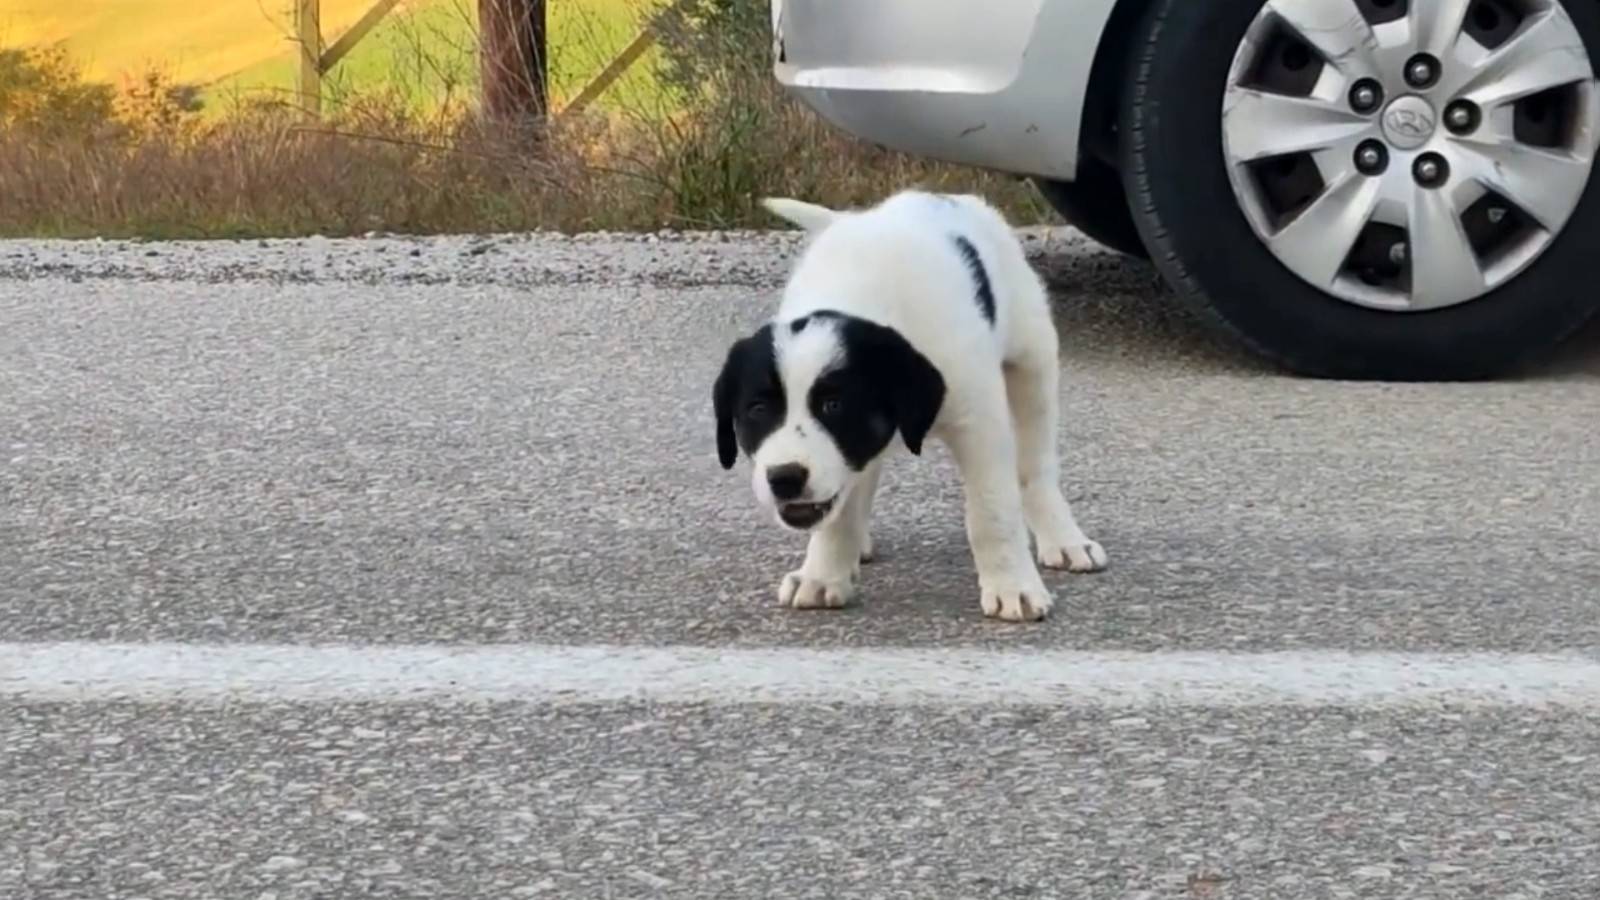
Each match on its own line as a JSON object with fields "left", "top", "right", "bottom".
{"left": 712, "top": 312, "right": 944, "bottom": 530}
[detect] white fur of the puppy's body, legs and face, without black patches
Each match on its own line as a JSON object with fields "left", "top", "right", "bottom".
{"left": 755, "top": 191, "right": 1107, "bottom": 621}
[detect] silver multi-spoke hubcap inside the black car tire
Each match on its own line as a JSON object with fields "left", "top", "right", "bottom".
{"left": 1222, "top": 0, "right": 1600, "bottom": 311}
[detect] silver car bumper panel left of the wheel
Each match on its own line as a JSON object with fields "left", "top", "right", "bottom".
{"left": 773, "top": 0, "right": 1115, "bottom": 179}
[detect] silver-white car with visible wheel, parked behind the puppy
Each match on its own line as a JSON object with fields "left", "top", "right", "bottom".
{"left": 773, "top": 0, "right": 1600, "bottom": 380}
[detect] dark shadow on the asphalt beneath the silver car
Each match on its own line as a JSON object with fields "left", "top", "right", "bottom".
{"left": 1034, "top": 245, "right": 1600, "bottom": 381}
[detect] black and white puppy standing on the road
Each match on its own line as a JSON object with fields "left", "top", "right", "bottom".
{"left": 712, "top": 191, "right": 1106, "bottom": 621}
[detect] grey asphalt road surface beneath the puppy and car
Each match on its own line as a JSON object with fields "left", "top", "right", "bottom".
{"left": 0, "top": 235, "right": 1600, "bottom": 900}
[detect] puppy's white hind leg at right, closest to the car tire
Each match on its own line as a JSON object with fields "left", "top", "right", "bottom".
{"left": 1005, "top": 320, "right": 1107, "bottom": 572}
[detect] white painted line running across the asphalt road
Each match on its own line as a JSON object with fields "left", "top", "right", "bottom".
{"left": 0, "top": 642, "right": 1600, "bottom": 708}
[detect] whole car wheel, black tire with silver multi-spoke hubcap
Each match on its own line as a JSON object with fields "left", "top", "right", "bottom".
{"left": 1118, "top": 0, "right": 1600, "bottom": 380}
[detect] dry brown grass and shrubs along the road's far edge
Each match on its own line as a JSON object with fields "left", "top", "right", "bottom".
{"left": 0, "top": 0, "right": 1046, "bottom": 237}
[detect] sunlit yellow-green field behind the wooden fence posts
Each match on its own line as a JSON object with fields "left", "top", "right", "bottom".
{"left": 0, "top": 0, "right": 659, "bottom": 107}
